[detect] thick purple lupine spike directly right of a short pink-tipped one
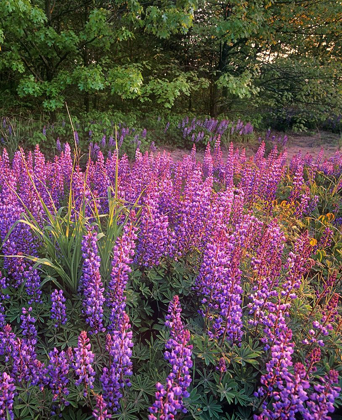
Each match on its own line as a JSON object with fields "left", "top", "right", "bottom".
{"left": 100, "top": 311, "right": 133, "bottom": 412}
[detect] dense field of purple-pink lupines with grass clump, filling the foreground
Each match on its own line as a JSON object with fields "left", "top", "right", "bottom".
{"left": 0, "top": 139, "right": 342, "bottom": 420}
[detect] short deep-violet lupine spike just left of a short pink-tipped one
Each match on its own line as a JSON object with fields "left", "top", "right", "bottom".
{"left": 47, "top": 348, "right": 70, "bottom": 406}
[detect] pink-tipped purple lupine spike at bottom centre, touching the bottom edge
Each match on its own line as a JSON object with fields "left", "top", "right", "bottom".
{"left": 148, "top": 296, "right": 192, "bottom": 420}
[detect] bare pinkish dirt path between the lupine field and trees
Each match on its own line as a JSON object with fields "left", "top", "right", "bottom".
{"left": 158, "top": 131, "right": 342, "bottom": 161}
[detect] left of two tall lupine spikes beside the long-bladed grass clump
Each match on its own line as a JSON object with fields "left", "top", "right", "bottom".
{"left": 81, "top": 231, "right": 105, "bottom": 334}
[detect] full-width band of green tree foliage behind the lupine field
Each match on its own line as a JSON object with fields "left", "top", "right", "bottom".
{"left": 0, "top": 0, "right": 342, "bottom": 125}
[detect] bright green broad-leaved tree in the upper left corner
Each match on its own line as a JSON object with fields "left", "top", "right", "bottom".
{"left": 0, "top": 0, "right": 193, "bottom": 112}
